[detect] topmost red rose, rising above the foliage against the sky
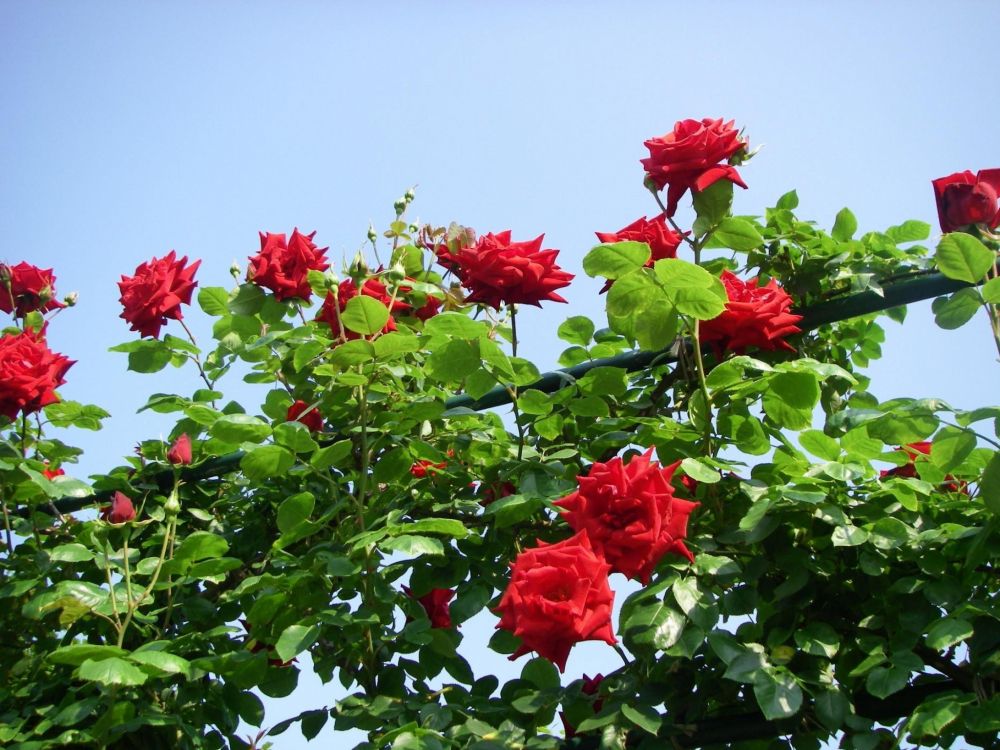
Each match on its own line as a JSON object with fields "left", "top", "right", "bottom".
{"left": 640, "top": 118, "right": 747, "bottom": 216}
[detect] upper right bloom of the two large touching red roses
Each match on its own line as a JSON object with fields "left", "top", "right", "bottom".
{"left": 556, "top": 448, "right": 698, "bottom": 584}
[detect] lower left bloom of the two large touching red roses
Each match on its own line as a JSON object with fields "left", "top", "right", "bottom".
{"left": 497, "top": 531, "right": 618, "bottom": 671}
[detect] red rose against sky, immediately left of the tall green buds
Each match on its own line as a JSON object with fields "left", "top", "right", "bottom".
{"left": 247, "top": 229, "right": 330, "bottom": 300}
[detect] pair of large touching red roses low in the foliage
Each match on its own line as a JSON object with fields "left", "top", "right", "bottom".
{"left": 497, "top": 449, "right": 698, "bottom": 671}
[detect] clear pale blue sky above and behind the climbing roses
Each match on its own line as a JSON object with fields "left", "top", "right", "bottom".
{"left": 0, "top": 0, "right": 1000, "bottom": 748}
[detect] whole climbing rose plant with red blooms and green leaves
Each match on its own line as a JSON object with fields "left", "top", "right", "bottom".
{"left": 0, "top": 123, "right": 1000, "bottom": 750}
